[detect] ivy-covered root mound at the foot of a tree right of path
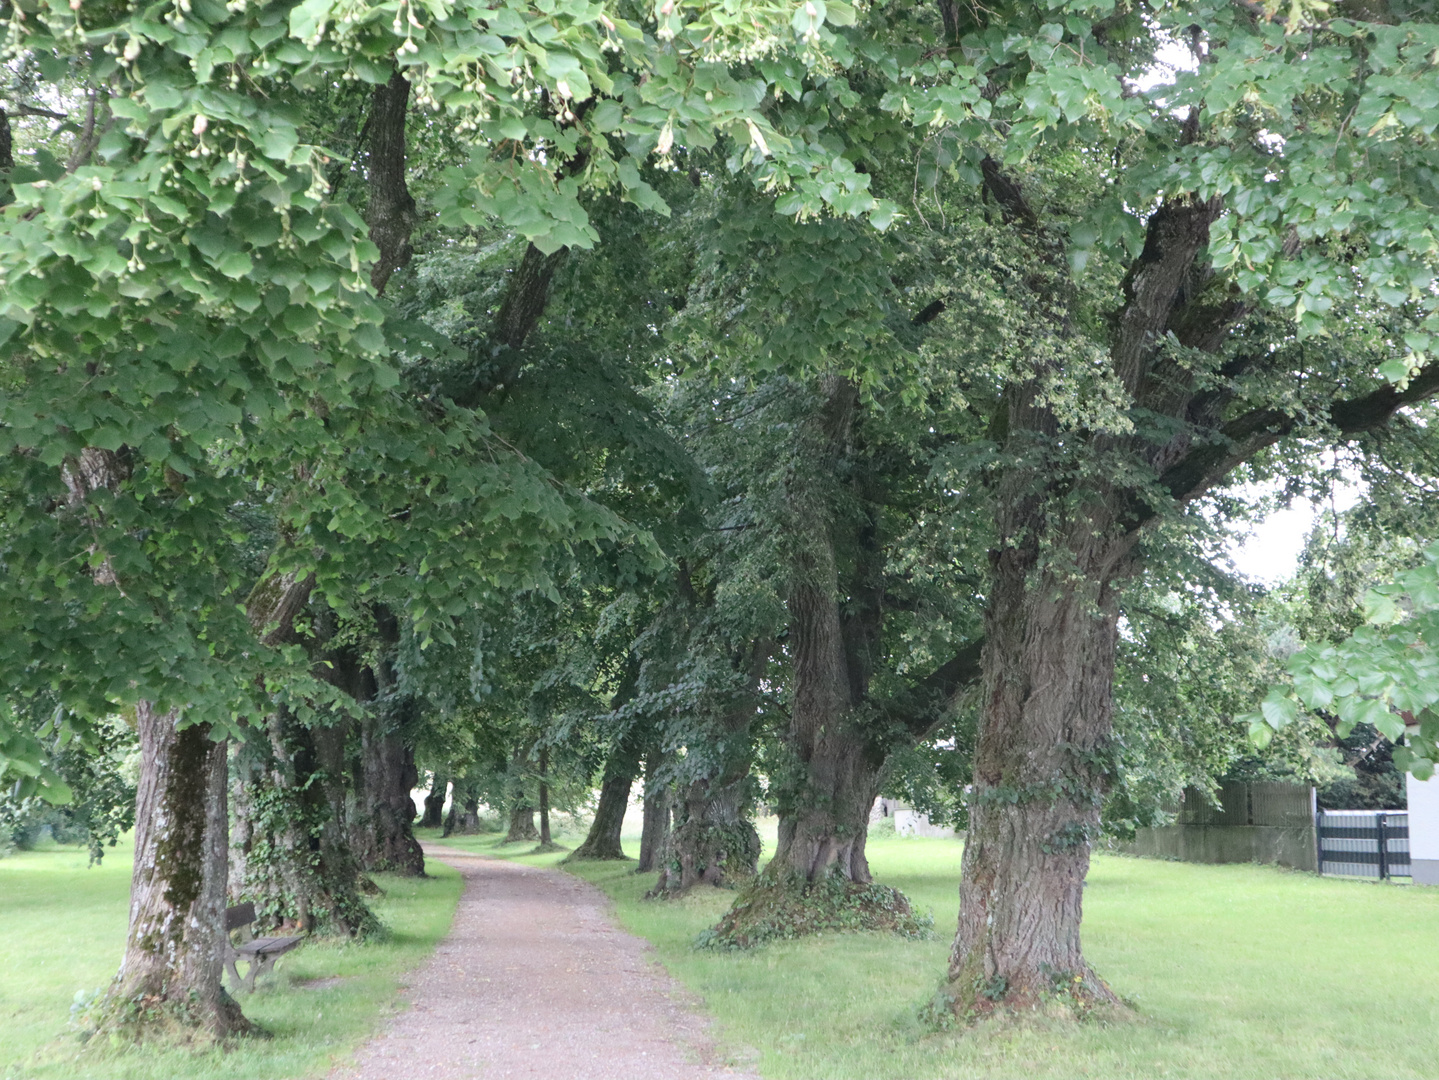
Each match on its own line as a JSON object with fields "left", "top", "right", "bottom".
{"left": 695, "top": 873, "right": 934, "bottom": 949}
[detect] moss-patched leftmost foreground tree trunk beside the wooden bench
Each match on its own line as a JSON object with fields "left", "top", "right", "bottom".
{"left": 99, "top": 702, "right": 250, "bottom": 1038}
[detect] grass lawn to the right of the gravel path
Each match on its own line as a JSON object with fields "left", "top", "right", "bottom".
{"left": 431, "top": 816, "right": 1439, "bottom": 1080}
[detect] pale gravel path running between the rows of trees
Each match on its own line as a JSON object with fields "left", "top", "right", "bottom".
{"left": 331, "top": 846, "right": 754, "bottom": 1080}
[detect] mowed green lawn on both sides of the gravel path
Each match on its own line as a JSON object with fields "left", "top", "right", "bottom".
{"left": 11, "top": 836, "right": 1439, "bottom": 1080}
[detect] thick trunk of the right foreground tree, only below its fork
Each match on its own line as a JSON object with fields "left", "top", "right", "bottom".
{"left": 950, "top": 532, "right": 1118, "bottom": 1008}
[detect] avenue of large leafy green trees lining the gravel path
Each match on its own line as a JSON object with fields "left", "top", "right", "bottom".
{"left": 0, "top": 0, "right": 1439, "bottom": 1037}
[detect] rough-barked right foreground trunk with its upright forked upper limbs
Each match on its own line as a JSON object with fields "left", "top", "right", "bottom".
{"left": 948, "top": 165, "right": 1226, "bottom": 1014}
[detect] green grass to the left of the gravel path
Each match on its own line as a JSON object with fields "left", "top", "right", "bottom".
{"left": 0, "top": 846, "right": 460, "bottom": 1080}
